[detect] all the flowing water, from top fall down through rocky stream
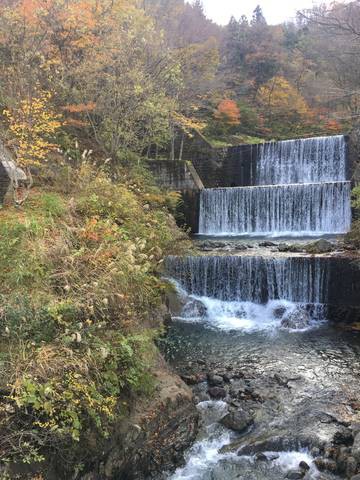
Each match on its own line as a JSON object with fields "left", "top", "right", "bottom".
{"left": 161, "top": 132, "right": 358, "bottom": 480}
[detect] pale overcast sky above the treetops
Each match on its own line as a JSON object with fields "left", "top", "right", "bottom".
{"left": 202, "top": 0, "right": 330, "bottom": 25}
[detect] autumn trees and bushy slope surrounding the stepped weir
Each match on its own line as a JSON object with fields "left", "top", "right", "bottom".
{"left": 0, "top": 0, "right": 360, "bottom": 480}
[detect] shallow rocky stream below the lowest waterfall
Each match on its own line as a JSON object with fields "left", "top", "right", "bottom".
{"left": 158, "top": 322, "right": 360, "bottom": 480}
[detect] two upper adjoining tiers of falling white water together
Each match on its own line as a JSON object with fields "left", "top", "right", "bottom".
{"left": 198, "top": 135, "right": 351, "bottom": 237}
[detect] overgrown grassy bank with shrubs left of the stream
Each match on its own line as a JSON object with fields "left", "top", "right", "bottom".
{"left": 0, "top": 167, "right": 189, "bottom": 478}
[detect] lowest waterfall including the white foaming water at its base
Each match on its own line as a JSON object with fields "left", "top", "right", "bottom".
{"left": 165, "top": 256, "right": 329, "bottom": 331}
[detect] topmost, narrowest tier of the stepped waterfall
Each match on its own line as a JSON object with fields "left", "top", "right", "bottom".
{"left": 256, "top": 135, "right": 346, "bottom": 185}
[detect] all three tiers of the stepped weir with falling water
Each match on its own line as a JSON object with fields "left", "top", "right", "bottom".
{"left": 165, "top": 135, "right": 357, "bottom": 325}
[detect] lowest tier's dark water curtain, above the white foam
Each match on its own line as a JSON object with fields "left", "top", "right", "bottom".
{"left": 165, "top": 256, "right": 329, "bottom": 304}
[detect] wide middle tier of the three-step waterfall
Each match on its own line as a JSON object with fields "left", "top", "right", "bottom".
{"left": 199, "top": 182, "right": 351, "bottom": 236}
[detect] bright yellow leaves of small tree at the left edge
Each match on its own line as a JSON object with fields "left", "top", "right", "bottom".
{"left": 3, "top": 91, "right": 62, "bottom": 167}
